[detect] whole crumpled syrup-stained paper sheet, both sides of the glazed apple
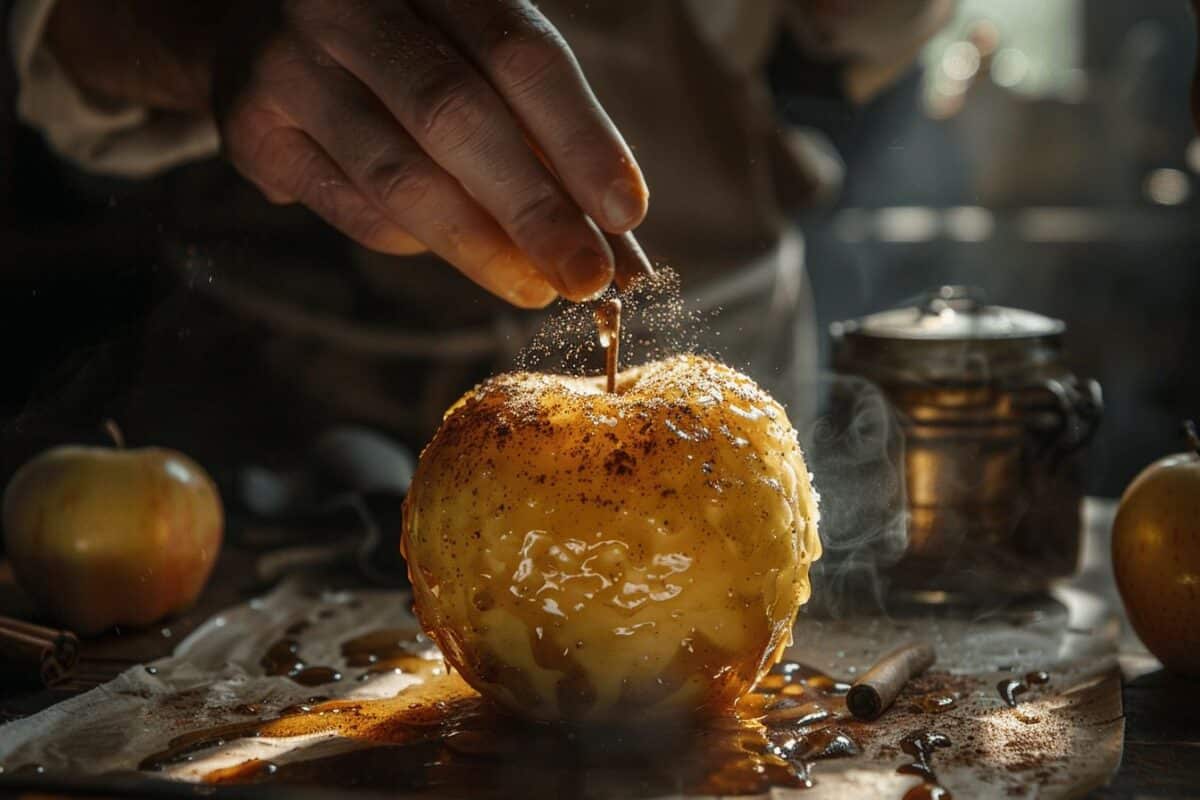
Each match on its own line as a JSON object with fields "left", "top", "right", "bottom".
{"left": 0, "top": 581, "right": 1123, "bottom": 799}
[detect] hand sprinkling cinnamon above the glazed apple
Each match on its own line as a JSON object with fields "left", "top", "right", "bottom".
{"left": 214, "top": 0, "right": 648, "bottom": 307}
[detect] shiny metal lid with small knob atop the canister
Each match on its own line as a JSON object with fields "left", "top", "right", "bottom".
{"left": 830, "top": 285, "right": 1066, "bottom": 385}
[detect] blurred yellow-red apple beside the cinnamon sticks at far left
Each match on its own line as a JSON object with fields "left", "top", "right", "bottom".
{"left": 4, "top": 446, "right": 223, "bottom": 634}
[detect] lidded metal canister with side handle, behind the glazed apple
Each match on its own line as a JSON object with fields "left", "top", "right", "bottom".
{"left": 832, "top": 287, "right": 1102, "bottom": 595}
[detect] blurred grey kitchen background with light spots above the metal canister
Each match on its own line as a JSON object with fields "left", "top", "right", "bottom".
{"left": 775, "top": 0, "right": 1200, "bottom": 497}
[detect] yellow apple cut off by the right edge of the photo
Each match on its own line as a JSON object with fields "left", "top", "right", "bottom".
{"left": 1112, "top": 423, "right": 1200, "bottom": 676}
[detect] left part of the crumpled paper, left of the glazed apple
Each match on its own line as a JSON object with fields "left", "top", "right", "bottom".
{"left": 0, "top": 579, "right": 440, "bottom": 780}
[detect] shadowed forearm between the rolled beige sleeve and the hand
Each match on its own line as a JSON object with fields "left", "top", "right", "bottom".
{"left": 46, "top": 0, "right": 229, "bottom": 114}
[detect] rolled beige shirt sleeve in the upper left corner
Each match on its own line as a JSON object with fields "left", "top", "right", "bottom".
{"left": 10, "top": 0, "right": 220, "bottom": 178}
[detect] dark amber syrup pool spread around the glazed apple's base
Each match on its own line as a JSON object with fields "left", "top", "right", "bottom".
{"left": 133, "top": 652, "right": 859, "bottom": 799}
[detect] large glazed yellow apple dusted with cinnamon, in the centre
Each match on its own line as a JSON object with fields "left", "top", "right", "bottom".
{"left": 401, "top": 356, "right": 821, "bottom": 722}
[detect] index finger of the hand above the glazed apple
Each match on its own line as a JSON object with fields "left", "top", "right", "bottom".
{"left": 414, "top": 0, "right": 649, "bottom": 234}
